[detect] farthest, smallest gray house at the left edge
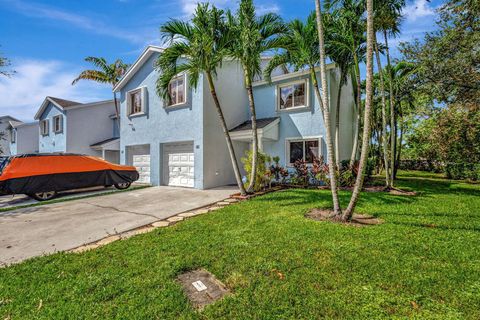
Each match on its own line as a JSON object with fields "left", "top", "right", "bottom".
{"left": 10, "top": 122, "right": 39, "bottom": 155}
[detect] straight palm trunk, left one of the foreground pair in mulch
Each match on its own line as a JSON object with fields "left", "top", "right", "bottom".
{"left": 315, "top": 0, "right": 342, "bottom": 217}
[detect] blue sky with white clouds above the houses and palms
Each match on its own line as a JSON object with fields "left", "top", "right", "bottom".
{"left": 0, "top": 0, "right": 442, "bottom": 121}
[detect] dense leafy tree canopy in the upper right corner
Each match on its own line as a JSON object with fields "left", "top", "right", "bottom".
{"left": 400, "top": 0, "right": 480, "bottom": 111}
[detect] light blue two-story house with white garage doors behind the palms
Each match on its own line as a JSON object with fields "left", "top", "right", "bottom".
{"left": 114, "top": 46, "right": 354, "bottom": 189}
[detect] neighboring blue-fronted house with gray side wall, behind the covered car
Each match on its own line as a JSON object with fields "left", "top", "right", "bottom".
{"left": 35, "top": 97, "right": 119, "bottom": 163}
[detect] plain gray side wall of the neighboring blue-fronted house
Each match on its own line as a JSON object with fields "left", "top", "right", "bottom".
{"left": 66, "top": 101, "right": 115, "bottom": 157}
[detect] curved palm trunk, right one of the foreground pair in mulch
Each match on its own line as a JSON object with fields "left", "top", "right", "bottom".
{"left": 342, "top": 0, "right": 374, "bottom": 221}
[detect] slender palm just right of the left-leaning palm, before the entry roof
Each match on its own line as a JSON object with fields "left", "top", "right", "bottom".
{"left": 227, "top": 0, "right": 285, "bottom": 192}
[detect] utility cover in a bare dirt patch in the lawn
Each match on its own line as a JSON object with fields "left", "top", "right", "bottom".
{"left": 177, "top": 269, "right": 229, "bottom": 310}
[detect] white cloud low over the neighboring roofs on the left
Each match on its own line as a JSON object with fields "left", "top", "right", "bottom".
{"left": 0, "top": 60, "right": 112, "bottom": 121}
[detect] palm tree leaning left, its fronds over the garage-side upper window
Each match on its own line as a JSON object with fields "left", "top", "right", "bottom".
{"left": 156, "top": 3, "right": 246, "bottom": 195}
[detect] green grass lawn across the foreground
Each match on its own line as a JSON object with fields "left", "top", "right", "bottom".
{"left": 0, "top": 172, "right": 480, "bottom": 319}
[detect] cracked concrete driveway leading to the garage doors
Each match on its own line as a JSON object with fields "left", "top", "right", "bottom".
{"left": 0, "top": 187, "right": 236, "bottom": 266}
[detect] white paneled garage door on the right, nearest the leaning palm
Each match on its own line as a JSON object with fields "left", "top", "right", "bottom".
{"left": 163, "top": 143, "right": 195, "bottom": 188}
